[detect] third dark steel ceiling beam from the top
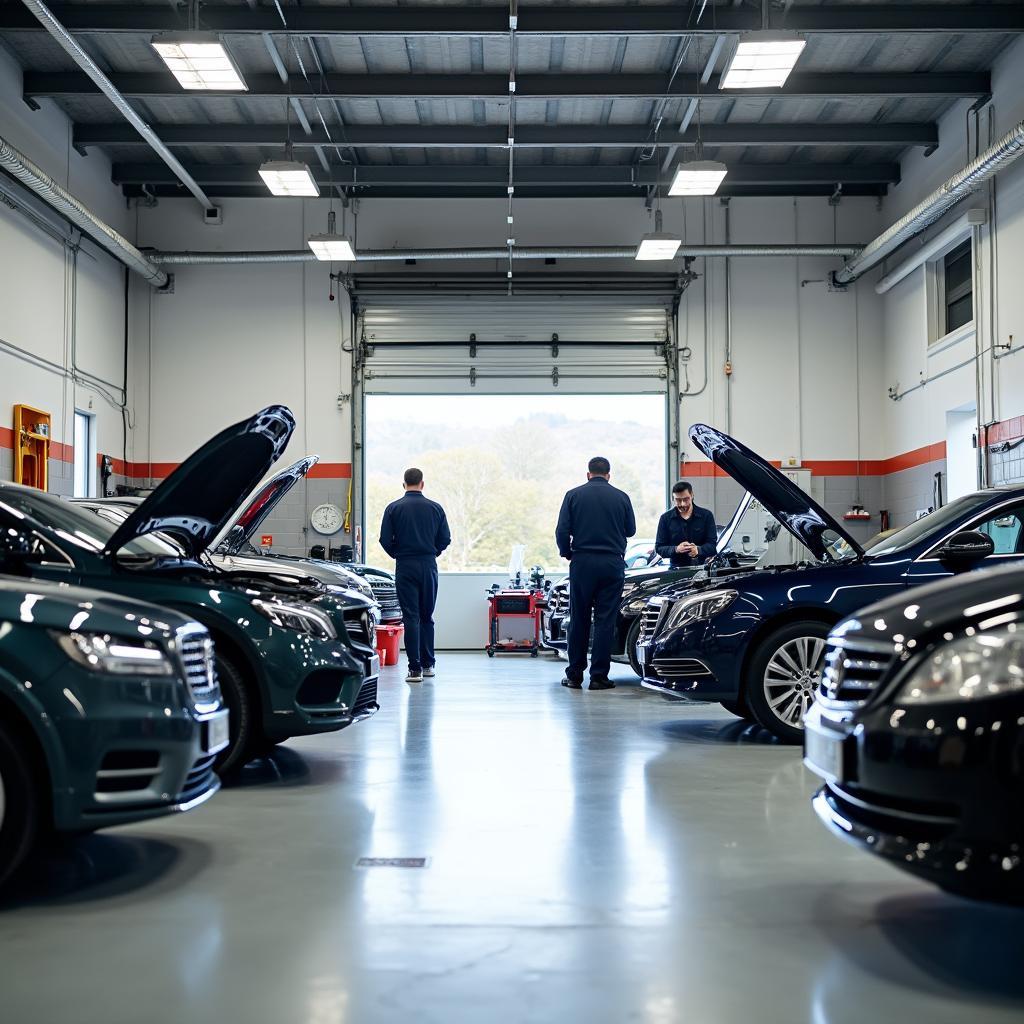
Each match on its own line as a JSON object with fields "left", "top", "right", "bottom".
{"left": 74, "top": 123, "right": 939, "bottom": 150}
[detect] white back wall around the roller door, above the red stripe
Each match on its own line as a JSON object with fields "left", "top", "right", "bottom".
{"left": 136, "top": 192, "right": 884, "bottom": 471}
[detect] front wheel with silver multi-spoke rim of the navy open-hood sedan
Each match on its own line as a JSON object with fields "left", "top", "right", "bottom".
{"left": 745, "top": 621, "right": 828, "bottom": 743}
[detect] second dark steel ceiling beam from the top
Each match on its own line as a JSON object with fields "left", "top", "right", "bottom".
{"left": 24, "top": 71, "right": 991, "bottom": 102}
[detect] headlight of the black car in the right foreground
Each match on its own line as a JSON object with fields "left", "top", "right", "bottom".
{"left": 896, "top": 625, "right": 1024, "bottom": 705}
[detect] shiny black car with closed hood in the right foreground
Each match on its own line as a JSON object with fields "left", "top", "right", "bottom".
{"left": 804, "top": 561, "right": 1024, "bottom": 905}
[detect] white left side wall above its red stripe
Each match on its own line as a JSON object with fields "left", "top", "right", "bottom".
{"left": 0, "top": 49, "right": 134, "bottom": 493}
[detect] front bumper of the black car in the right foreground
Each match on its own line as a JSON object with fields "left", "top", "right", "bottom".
{"left": 804, "top": 696, "right": 1024, "bottom": 903}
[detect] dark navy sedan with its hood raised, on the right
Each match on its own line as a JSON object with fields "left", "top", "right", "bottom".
{"left": 636, "top": 424, "right": 1024, "bottom": 742}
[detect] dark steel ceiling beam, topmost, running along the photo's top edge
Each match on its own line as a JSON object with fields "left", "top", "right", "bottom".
{"left": 0, "top": 3, "right": 1024, "bottom": 37}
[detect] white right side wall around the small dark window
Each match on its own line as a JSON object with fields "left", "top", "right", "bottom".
{"left": 864, "top": 40, "right": 1024, "bottom": 453}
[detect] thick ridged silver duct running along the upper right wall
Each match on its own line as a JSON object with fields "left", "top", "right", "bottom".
{"left": 834, "top": 121, "right": 1024, "bottom": 285}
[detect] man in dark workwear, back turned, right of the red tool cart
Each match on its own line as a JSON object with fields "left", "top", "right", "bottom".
{"left": 555, "top": 457, "right": 637, "bottom": 690}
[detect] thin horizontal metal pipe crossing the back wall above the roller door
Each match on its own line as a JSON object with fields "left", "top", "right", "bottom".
{"left": 150, "top": 245, "right": 861, "bottom": 266}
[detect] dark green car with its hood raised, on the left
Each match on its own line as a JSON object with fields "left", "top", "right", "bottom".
{"left": 0, "top": 406, "right": 378, "bottom": 770}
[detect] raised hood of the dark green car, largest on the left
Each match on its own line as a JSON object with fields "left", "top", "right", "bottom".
{"left": 103, "top": 406, "right": 295, "bottom": 558}
